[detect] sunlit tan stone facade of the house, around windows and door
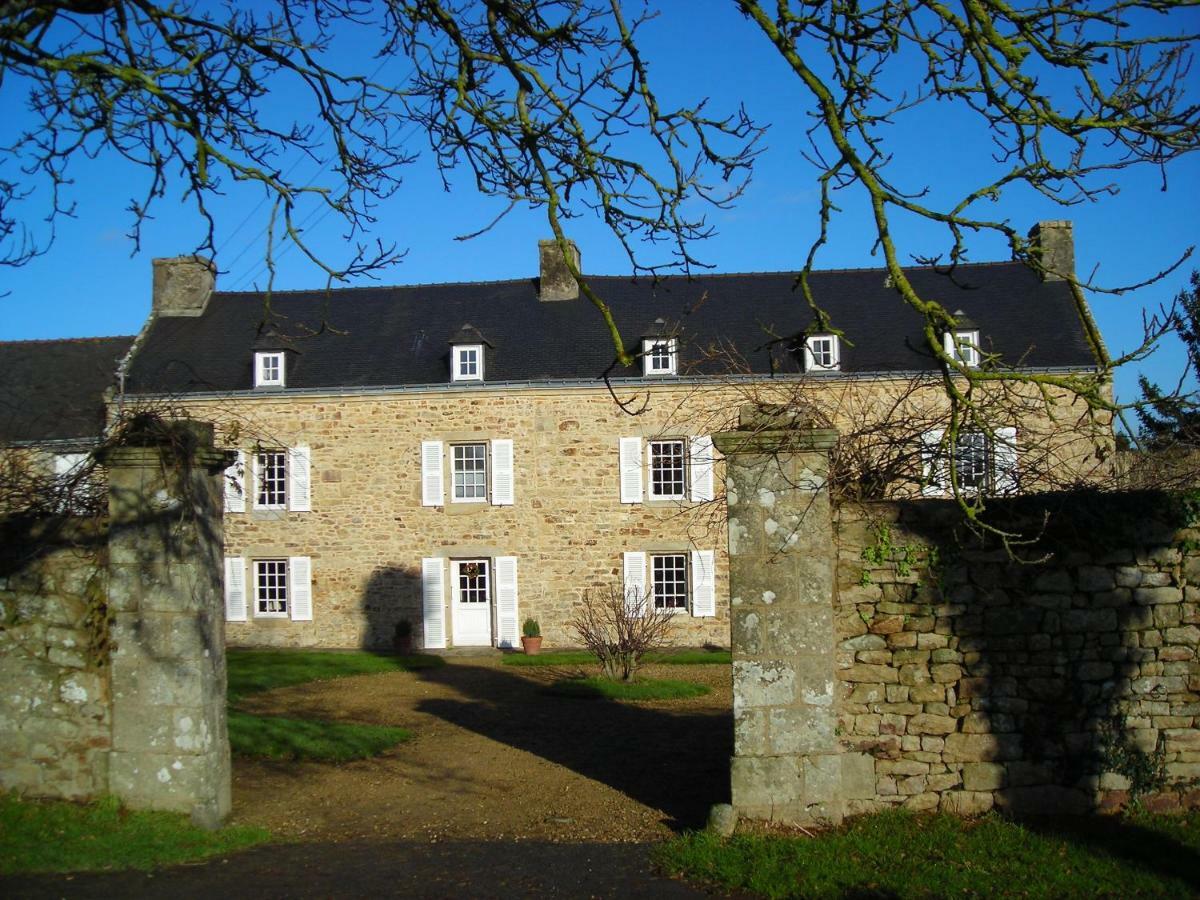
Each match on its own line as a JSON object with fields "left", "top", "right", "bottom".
{"left": 174, "top": 379, "right": 1096, "bottom": 647}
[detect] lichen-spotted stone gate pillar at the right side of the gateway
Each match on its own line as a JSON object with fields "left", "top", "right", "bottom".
{"left": 713, "top": 406, "right": 842, "bottom": 824}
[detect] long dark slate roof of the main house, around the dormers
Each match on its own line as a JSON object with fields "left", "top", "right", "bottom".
{"left": 128, "top": 263, "right": 1096, "bottom": 394}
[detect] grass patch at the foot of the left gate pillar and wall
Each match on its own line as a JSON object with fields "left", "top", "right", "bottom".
{"left": 0, "top": 794, "right": 271, "bottom": 875}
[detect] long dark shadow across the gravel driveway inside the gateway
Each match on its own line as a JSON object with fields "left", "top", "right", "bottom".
{"left": 416, "top": 664, "right": 733, "bottom": 830}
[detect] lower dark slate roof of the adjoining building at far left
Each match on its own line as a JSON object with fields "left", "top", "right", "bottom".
{"left": 0, "top": 337, "right": 133, "bottom": 444}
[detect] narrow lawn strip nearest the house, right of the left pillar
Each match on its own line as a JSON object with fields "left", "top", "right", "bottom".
{"left": 227, "top": 650, "right": 445, "bottom": 701}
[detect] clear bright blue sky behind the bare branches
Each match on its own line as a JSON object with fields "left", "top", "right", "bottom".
{"left": 0, "top": 0, "right": 1200, "bottom": 410}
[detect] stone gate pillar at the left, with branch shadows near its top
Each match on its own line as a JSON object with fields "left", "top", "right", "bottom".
{"left": 103, "top": 421, "right": 229, "bottom": 827}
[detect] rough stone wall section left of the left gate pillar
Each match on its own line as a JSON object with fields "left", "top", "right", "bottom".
{"left": 0, "top": 522, "right": 112, "bottom": 799}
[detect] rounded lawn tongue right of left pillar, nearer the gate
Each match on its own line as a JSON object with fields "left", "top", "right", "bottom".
{"left": 229, "top": 709, "right": 413, "bottom": 762}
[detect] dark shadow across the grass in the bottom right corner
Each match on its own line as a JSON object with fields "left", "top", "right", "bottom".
{"left": 1015, "top": 815, "right": 1200, "bottom": 894}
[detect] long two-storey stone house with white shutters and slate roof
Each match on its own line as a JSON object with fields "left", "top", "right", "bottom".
{"left": 0, "top": 222, "right": 1111, "bottom": 649}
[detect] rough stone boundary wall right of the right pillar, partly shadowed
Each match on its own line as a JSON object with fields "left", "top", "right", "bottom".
{"left": 835, "top": 493, "right": 1200, "bottom": 814}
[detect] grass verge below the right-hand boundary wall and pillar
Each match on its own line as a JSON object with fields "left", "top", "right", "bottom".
{"left": 658, "top": 811, "right": 1200, "bottom": 898}
